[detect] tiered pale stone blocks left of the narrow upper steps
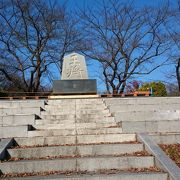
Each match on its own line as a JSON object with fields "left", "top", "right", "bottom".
{"left": 0, "top": 100, "right": 45, "bottom": 138}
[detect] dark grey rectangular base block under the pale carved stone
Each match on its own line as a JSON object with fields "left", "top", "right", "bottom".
{"left": 53, "top": 79, "right": 97, "bottom": 94}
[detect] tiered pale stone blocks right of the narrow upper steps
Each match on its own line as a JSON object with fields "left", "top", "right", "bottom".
{"left": 104, "top": 97, "right": 180, "bottom": 144}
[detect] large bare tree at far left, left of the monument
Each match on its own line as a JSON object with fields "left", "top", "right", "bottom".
{"left": 0, "top": 0, "right": 67, "bottom": 92}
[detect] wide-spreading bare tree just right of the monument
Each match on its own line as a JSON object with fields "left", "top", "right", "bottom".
{"left": 80, "top": 0, "right": 169, "bottom": 93}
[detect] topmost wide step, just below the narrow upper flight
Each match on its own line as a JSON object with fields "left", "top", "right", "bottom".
{"left": 15, "top": 134, "right": 136, "bottom": 146}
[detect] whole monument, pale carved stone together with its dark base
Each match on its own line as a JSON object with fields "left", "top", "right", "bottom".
{"left": 53, "top": 53, "right": 97, "bottom": 94}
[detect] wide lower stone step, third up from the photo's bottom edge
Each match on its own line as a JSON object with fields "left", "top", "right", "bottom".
{"left": 8, "top": 143, "right": 143, "bottom": 159}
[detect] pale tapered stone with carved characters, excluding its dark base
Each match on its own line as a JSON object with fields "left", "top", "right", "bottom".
{"left": 61, "top": 53, "right": 88, "bottom": 80}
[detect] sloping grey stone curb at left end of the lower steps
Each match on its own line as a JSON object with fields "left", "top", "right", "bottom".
{"left": 0, "top": 138, "right": 14, "bottom": 160}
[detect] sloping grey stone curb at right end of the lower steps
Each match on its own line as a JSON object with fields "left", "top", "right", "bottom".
{"left": 137, "top": 133, "right": 180, "bottom": 180}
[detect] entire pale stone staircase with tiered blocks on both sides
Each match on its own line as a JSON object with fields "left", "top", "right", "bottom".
{"left": 0, "top": 98, "right": 180, "bottom": 180}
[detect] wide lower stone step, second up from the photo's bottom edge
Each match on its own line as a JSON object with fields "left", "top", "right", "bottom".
{"left": 0, "top": 156, "right": 154, "bottom": 174}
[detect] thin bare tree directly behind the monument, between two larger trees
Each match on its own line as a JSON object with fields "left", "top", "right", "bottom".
{"left": 50, "top": 11, "right": 85, "bottom": 76}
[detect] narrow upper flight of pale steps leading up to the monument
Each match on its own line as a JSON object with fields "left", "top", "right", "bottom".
{"left": 29, "top": 99, "right": 122, "bottom": 138}
